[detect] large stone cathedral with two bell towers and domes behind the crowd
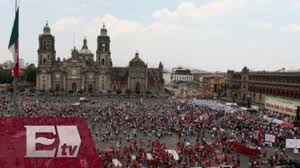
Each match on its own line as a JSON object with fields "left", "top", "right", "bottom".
{"left": 36, "top": 23, "right": 164, "bottom": 94}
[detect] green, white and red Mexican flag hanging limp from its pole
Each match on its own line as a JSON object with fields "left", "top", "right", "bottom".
{"left": 8, "top": 8, "right": 19, "bottom": 78}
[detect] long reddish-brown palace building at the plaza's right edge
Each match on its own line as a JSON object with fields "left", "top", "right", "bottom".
{"left": 227, "top": 67, "right": 300, "bottom": 104}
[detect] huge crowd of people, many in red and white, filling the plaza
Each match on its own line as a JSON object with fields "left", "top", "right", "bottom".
{"left": 0, "top": 92, "right": 300, "bottom": 168}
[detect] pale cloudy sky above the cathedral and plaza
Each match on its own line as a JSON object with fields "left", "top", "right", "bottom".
{"left": 0, "top": 0, "right": 300, "bottom": 71}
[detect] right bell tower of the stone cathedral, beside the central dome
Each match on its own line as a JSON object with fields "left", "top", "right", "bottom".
{"left": 96, "top": 25, "right": 112, "bottom": 67}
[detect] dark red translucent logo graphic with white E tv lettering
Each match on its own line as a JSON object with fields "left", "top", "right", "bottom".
{"left": 0, "top": 118, "right": 102, "bottom": 168}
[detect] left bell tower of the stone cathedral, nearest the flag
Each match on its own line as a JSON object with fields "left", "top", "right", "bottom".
{"left": 38, "top": 22, "right": 56, "bottom": 66}
